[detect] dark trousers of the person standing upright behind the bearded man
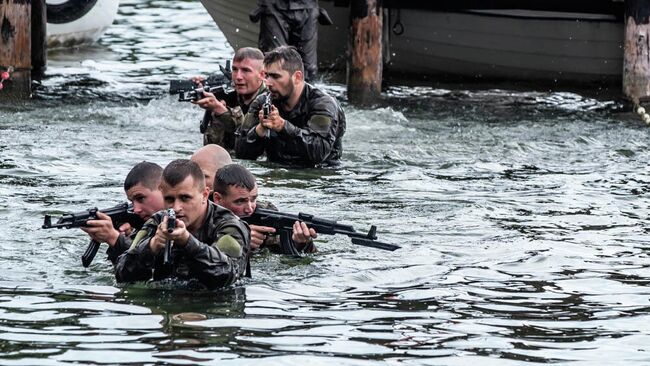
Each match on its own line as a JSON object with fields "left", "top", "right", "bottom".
{"left": 259, "top": 8, "right": 318, "bottom": 81}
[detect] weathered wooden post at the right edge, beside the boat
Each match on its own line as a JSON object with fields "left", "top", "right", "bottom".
{"left": 623, "top": 0, "right": 650, "bottom": 104}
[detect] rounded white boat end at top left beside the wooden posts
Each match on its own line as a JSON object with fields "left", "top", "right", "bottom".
{"left": 46, "top": 0, "right": 119, "bottom": 48}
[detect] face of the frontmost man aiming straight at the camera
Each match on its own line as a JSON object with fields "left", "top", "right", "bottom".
{"left": 160, "top": 176, "right": 210, "bottom": 232}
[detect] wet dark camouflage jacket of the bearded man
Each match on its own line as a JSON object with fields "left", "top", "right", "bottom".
{"left": 235, "top": 83, "right": 345, "bottom": 166}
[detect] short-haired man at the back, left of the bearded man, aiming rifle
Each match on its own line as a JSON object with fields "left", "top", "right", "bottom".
{"left": 192, "top": 47, "right": 266, "bottom": 151}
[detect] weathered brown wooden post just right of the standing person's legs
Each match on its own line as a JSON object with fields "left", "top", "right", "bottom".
{"left": 347, "top": 0, "right": 383, "bottom": 105}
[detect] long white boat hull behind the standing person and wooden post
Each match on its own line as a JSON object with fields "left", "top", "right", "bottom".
{"left": 201, "top": 0, "right": 624, "bottom": 82}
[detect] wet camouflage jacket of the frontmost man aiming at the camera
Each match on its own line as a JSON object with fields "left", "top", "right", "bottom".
{"left": 115, "top": 202, "right": 250, "bottom": 288}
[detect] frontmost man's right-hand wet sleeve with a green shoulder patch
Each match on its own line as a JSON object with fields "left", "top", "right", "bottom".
{"left": 184, "top": 221, "right": 250, "bottom": 288}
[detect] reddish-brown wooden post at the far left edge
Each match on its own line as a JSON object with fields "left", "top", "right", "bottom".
{"left": 0, "top": 0, "right": 37, "bottom": 101}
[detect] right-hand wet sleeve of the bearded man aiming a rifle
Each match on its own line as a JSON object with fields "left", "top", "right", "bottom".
{"left": 278, "top": 97, "right": 338, "bottom": 164}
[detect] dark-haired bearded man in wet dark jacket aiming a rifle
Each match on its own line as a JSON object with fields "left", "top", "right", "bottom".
{"left": 235, "top": 46, "right": 345, "bottom": 166}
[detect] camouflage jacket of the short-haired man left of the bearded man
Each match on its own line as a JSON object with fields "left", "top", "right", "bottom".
{"left": 203, "top": 83, "right": 266, "bottom": 151}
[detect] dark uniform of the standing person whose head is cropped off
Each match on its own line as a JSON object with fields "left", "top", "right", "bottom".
{"left": 251, "top": 0, "right": 319, "bottom": 80}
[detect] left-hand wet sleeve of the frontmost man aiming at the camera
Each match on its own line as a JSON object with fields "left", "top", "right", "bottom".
{"left": 115, "top": 218, "right": 158, "bottom": 282}
